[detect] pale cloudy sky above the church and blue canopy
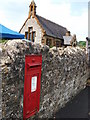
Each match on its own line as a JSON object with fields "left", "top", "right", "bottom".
{"left": 0, "top": 0, "right": 88, "bottom": 41}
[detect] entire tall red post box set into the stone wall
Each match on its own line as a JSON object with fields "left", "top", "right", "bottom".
{"left": 23, "top": 55, "right": 42, "bottom": 119}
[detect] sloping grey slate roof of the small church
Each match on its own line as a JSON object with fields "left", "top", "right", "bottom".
{"left": 36, "top": 15, "right": 67, "bottom": 39}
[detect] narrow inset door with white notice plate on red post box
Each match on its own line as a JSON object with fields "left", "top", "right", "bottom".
{"left": 25, "top": 73, "right": 39, "bottom": 118}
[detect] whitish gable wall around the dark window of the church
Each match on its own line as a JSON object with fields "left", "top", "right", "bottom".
{"left": 20, "top": 18, "right": 43, "bottom": 44}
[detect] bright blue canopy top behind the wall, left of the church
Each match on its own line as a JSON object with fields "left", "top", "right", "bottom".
{"left": 0, "top": 24, "right": 24, "bottom": 39}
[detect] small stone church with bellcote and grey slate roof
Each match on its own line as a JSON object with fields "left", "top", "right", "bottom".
{"left": 20, "top": 0, "right": 68, "bottom": 47}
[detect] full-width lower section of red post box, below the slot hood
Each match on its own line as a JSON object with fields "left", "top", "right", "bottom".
{"left": 24, "top": 68, "right": 41, "bottom": 118}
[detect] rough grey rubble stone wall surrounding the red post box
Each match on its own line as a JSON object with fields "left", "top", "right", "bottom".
{"left": 0, "top": 40, "right": 89, "bottom": 119}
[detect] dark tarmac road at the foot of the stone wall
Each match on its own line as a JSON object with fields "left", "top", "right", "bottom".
{"left": 55, "top": 87, "right": 90, "bottom": 120}
